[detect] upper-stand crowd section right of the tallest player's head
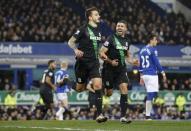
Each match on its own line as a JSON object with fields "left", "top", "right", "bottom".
{"left": 75, "top": 0, "right": 191, "bottom": 45}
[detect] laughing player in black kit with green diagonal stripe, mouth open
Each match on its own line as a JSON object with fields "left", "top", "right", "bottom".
{"left": 100, "top": 20, "right": 138, "bottom": 123}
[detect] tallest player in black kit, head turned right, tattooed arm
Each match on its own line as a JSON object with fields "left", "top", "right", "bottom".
{"left": 68, "top": 7, "right": 107, "bottom": 123}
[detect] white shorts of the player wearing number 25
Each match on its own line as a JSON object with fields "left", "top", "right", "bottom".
{"left": 142, "top": 75, "right": 159, "bottom": 92}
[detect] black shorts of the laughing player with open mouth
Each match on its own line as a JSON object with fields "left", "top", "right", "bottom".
{"left": 102, "top": 67, "right": 129, "bottom": 89}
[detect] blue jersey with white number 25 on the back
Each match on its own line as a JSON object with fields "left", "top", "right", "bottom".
{"left": 139, "top": 45, "right": 163, "bottom": 75}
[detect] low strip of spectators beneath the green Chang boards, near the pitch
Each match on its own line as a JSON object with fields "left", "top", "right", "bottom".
{"left": 0, "top": 104, "right": 191, "bottom": 120}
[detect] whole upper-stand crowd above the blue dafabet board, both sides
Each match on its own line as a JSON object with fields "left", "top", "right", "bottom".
{"left": 0, "top": 0, "right": 191, "bottom": 45}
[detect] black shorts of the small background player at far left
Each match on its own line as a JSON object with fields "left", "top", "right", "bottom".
{"left": 40, "top": 86, "right": 53, "bottom": 106}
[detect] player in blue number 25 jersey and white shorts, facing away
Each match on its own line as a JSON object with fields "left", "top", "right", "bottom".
{"left": 139, "top": 34, "right": 166, "bottom": 120}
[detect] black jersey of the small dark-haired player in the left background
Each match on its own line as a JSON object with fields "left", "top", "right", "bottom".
{"left": 42, "top": 69, "right": 54, "bottom": 88}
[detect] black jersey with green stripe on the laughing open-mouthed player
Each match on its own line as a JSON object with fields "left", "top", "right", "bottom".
{"left": 103, "top": 34, "right": 131, "bottom": 67}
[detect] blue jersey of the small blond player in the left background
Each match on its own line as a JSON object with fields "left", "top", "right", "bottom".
{"left": 55, "top": 69, "right": 70, "bottom": 93}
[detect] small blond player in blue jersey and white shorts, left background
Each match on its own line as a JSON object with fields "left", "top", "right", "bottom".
{"left": 55, "top": 61, "right": 70, "bottom": 120}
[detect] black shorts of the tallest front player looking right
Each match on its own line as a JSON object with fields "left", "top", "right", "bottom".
{"left": 75, "top": 60, "right": 101, "bottom": 84}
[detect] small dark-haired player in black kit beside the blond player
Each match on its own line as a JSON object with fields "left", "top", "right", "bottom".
{"left": 40, "top": 60, "right": 56, "bottom": 119}
